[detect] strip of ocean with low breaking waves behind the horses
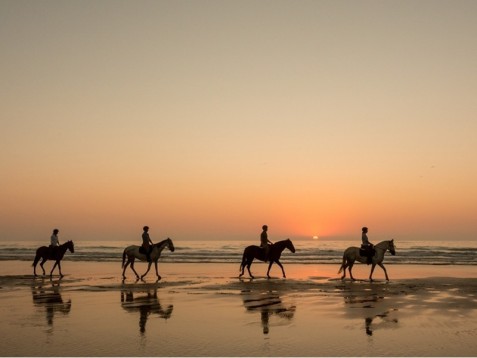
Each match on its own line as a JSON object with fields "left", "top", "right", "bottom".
{"left": 0, "top": 239, "right": 477, "bottom": 265}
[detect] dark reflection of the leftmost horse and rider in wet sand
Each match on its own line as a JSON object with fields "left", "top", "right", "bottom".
{"left": 31, "top": 280, "right": 71, "bottom": 326}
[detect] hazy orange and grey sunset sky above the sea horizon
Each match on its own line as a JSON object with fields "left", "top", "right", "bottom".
{"left": 0, "top": 0, "right": 477, "bottom": 243}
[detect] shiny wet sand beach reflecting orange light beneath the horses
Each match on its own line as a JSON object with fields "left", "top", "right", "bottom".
{"left": 0, "top": 261, "right": 477, "bottom": 356}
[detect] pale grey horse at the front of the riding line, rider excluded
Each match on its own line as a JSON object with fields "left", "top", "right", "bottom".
{"left": 338, "top": 239, "right": 396, "bottom": 281}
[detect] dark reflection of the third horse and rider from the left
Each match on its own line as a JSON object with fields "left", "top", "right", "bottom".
{"left": 242, "top": 290, "right": 295, "bottom": 334}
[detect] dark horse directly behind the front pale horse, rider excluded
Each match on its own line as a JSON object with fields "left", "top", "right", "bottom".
{"left": 239, "top": 239, "right": 295, "bottom": 278}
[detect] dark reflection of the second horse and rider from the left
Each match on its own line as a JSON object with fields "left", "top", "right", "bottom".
{"left": 121, "top": 288, "right": 174, "bottom": 334}
